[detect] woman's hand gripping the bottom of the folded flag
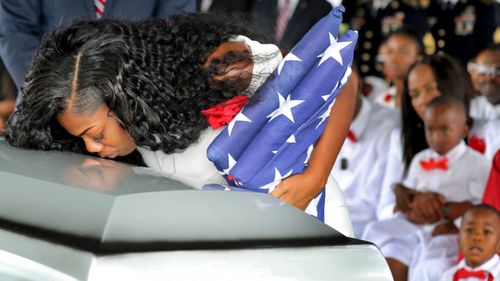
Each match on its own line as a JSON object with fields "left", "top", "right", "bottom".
{"left": 270, "top": 173, "right": 324, "bottom": 210}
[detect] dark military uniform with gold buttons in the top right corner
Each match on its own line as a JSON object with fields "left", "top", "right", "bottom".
{"left": 426, "top": 0, "right": 496, "bottom": 65}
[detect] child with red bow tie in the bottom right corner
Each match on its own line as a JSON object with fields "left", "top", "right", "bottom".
{"left": 441, "top": 204, "right": 500, "bottom": 281}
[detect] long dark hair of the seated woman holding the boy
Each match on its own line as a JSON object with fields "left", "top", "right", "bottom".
{"left": 401, "top": 54, "right": 474, "bottom": 173}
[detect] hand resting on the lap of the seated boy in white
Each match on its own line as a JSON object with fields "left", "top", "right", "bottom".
{"left": 409, "top": 192, "right": 446, "bottom": 224}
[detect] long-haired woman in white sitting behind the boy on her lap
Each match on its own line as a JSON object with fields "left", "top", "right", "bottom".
{"left": 378, "top": 54, "right": 472, "bottom": 219}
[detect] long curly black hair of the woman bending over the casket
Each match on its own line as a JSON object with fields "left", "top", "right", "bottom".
{"left": 6, "top": 14, "right": 263, "bottom": 153}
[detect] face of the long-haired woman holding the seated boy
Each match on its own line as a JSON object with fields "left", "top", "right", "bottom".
{"left": 408, "top": 64, "right": 441, "bottom": 119}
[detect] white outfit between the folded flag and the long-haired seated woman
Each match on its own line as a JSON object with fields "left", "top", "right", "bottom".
{"left": 331, "top": 94, "right": 399, "bottom": 238}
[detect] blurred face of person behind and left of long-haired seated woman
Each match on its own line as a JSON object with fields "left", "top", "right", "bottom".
{"left": 383, "top": 35, "right": 421, "bottom": 80}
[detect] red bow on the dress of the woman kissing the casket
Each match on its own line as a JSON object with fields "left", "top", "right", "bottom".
{"left": 201, "top": 96, "right": 248, "bottom": 130}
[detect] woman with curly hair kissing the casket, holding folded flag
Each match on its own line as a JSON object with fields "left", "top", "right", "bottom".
{"left": 3, "top": 15, "right": 356, "bottom": 210}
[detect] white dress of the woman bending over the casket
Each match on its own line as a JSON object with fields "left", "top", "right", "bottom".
{"left": 138, "top": 35, "right": 353, "bottom": 237}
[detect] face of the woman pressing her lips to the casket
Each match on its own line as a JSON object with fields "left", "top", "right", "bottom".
{"left": 57, "top": 104, "right": 137, "bottom": 158}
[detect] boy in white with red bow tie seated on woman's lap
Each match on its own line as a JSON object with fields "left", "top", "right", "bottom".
{"left": 363, "top": 95, "right": 490, "bottom": 281}
